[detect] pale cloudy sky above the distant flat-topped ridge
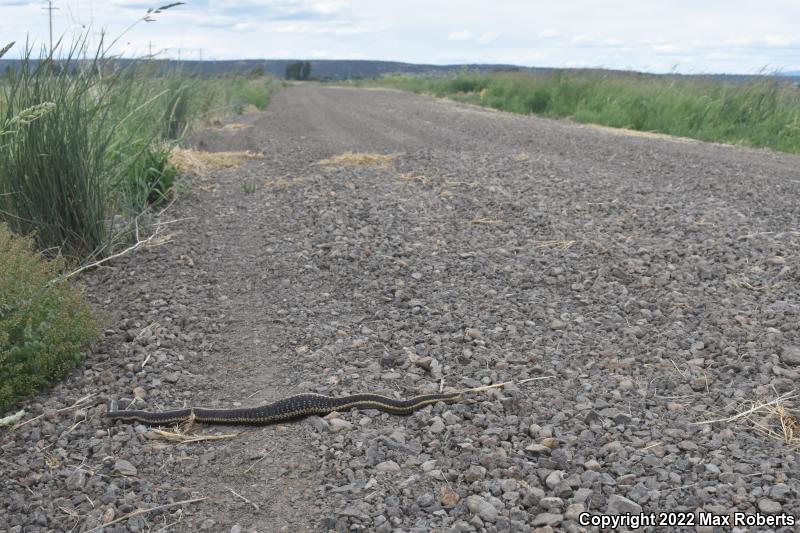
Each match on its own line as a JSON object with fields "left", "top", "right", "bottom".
{"left": 0, "top": 0, "right": 800, "bottom": 73}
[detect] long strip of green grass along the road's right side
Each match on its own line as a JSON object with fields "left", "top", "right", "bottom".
{"left": 355, "top": 71, "right": 800, "bottom": 153}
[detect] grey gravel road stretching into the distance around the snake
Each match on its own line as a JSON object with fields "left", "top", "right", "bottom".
{"left": 0, "top": 85, "right": 800, "bottom": 533}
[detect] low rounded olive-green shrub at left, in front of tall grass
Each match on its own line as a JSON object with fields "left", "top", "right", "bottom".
{"left": 0, "top": 224, "right": 97, "bottom": 412}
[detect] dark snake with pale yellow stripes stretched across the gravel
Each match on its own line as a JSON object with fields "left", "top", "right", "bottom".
{"left": 106, "top": 392, "right": 462, "bottom": 426}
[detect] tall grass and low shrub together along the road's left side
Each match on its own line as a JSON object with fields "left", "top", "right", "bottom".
{"left": 0, "top": 42, "right": 278, "bottom": 412}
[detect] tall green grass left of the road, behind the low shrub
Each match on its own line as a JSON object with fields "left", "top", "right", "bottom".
{"left": 0, "top": 41, "right": 277, "bottom": 261}
